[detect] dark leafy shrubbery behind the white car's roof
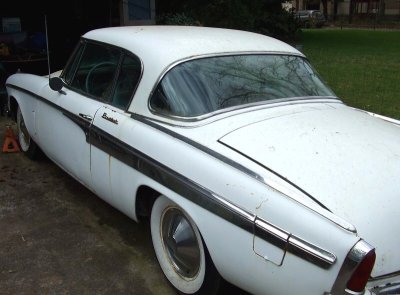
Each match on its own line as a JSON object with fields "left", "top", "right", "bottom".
{"left": 156, "top": 0, "right": 299, "bottom": 40}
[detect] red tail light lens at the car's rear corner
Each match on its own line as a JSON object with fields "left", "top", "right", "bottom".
{"left": 347, "top": 250, "right": 376, "bottom": 292}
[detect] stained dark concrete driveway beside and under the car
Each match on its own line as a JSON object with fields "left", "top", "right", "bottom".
{"left": 0, "top": 116, "right": 247, "bottom": 295}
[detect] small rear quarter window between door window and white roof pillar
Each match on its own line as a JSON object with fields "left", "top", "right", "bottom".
{"left": 111, "top": 55, "right": 141, "bottom": 109}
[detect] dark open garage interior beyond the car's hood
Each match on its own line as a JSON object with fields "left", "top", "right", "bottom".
{"left": 0, "top": 0, "right": 155, "bottom": 116}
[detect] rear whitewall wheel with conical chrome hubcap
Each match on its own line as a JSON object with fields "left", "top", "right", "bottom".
{"left": 150, "top": 196, "right": 221, "bottom": 294}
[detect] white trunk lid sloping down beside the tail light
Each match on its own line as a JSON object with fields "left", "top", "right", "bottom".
{"left": 219, "top": 106, "right": 400, "bottom": 277}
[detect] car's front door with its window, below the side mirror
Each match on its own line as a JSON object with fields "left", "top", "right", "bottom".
{"left": 36, "top": 42, "right": 120, "bottom": 189}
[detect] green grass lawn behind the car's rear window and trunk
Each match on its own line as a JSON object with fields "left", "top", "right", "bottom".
{"left": 299, "top": 29, "right": 400, "bottom": 119}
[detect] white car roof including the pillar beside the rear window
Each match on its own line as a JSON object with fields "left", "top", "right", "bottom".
{"left": 83, "top": 26, "right": 304, "bottom": 116}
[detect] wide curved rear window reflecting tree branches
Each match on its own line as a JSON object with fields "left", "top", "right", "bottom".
{"left": 150, "top": 55, "right": 336, "bottom": 117}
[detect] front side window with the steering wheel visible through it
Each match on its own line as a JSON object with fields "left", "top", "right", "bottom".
{"left": 66, "top": 43, "right": 120, "bottom": 100}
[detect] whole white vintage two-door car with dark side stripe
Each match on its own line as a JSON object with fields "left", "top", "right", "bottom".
{"left": 6, "top": 26, "right": 400, "bottom": 295}
